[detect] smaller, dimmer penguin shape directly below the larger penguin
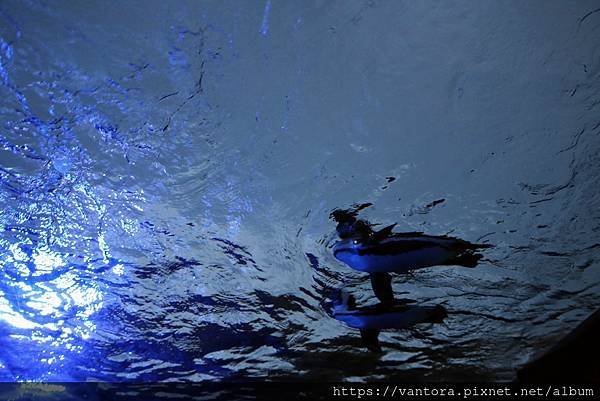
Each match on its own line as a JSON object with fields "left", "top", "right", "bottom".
{"left": 333, "top": 292, "right": 447, "bottom": 352}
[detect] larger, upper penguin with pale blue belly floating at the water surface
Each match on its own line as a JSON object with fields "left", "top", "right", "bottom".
{"left": 331, "top": 209, "right": 492, "bottom": 303}
